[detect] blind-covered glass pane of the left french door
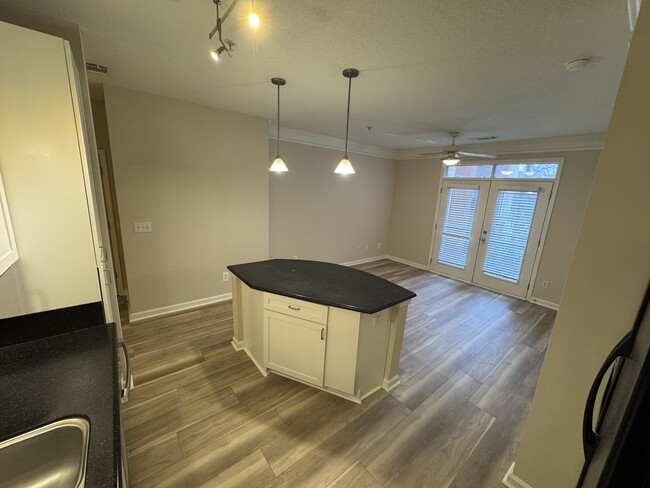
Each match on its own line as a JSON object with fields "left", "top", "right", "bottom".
{"left": 438, "top": 188, "right": 478, "bottom": 269}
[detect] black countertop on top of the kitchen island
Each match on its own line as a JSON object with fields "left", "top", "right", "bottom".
{"left": 228, "top": 259, "right": 416, "bottom": 314}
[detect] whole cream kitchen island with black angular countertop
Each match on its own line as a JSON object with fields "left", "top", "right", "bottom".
{"left": 228, "top": 259, "right": 416, "bottom": 402}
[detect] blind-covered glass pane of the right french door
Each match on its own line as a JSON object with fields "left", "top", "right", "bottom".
{"left": 483, "top": 190, "right": 538, "bottom": 283}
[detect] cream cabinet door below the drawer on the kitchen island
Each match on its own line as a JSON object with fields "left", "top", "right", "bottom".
{"left": 264, "top": 310, "right": 327, "bottom": 386}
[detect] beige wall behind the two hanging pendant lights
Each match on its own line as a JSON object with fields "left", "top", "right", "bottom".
{"left": 267, "top": 140, "right": 395, "bottom": 263}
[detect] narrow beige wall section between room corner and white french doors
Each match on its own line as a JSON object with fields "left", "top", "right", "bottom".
{"left": 389, "top": 159, "right": 442, "bottom": 268}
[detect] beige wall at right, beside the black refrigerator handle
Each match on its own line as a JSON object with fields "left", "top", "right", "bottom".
{"left": 515, "top": 3, "right": 650, "bottom": 488}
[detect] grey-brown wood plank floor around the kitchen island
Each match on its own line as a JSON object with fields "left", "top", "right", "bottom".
{"left": 123, "top": 260, "right": 555, "bottom": 488}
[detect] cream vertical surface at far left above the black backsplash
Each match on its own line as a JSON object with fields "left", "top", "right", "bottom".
{"left": 0, "top": 22, "right": 101, "bottom": 318}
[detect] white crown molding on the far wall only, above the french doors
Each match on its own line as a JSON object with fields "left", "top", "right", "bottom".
{"left": 395, "top": 134, "right": 605, "bottom": 160}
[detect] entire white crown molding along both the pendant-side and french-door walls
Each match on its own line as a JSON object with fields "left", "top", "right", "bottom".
{"left": 269, "top": 123, "right": 605, "bottom": 161}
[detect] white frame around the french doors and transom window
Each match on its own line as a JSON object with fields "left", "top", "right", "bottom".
{"left": 427, "top": 157, "right": 564, "bottom": 301}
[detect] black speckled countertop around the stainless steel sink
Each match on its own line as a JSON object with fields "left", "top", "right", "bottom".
{"left": 0, "top": 324, "right": 120, "bottom": 487}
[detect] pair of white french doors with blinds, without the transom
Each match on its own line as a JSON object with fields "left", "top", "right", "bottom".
{"left": 431, "top": 181, "right": 553, "bottom": 297}
